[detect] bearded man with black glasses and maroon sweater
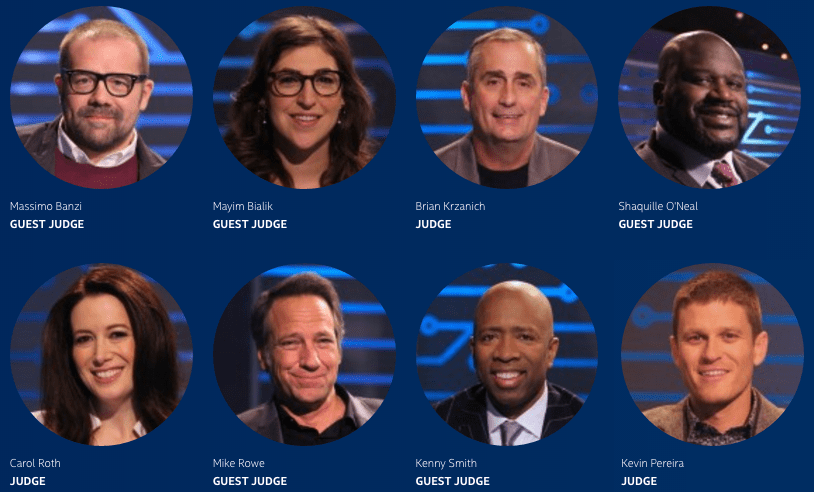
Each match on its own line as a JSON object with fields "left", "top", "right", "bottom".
{"left": 17, "top": 19, "right": 164, "bottom": 188}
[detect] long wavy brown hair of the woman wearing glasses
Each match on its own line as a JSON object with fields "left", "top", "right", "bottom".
{"left": 224, "top": 16, "right": 373, "bottom": 188}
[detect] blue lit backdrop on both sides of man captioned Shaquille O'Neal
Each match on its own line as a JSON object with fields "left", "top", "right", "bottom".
{"left": 619, "top": 29, "right": 800, "bottom": 164}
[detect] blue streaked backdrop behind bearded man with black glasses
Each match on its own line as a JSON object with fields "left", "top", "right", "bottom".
{"left": 11, "top": 7, "right": 192, "bottom": 159}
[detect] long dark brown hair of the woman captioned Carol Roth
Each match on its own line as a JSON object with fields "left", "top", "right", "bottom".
{"left": 40, "top": 265, "right": 179, "bottom": 444}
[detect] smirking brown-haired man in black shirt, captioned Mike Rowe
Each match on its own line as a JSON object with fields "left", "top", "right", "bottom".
{"left": 238, "top": 272, "right": 382, "bottom": 446}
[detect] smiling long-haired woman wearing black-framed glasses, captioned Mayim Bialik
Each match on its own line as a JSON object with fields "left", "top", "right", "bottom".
{"left": 224, "top": 16, "right": 373, "bottom": 188}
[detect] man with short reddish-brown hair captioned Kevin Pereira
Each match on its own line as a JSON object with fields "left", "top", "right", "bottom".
{"left": 644, "top": 271, "right": 783, "bottom": 446}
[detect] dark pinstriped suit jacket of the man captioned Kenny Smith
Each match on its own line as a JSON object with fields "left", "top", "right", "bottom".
{"left": 433, "top": 382, "right": 583, "bottom": 444}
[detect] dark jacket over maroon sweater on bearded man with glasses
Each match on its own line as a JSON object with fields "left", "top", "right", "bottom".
{"left": 17, "top": 116, "right": 166, "bottom": 180}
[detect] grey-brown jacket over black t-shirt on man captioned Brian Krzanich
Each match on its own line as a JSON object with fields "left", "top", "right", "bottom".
{"left": 435, "top": 133, "right": 579, "bottom": 186}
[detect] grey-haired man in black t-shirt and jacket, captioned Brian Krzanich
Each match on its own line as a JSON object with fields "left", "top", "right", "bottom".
{"left": 435, "top": 28, "right": 579, "bottom": 188}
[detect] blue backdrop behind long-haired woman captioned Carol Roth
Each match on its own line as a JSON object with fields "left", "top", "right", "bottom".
{"left": 10, "top": 265, "right": 192, "bottom": 412}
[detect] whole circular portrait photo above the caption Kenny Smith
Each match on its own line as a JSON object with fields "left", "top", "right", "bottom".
{"left": 416, "top": 263, "right": 597, "bottom": 446}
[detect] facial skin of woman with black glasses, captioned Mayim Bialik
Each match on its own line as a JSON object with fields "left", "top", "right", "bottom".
{"left": 267, "top": 44, "right": 345, "bottom": 155}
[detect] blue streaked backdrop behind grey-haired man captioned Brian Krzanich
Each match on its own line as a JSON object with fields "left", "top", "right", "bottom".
{"left": 416, "top": 7, "right": 598, "bottom": 154}
